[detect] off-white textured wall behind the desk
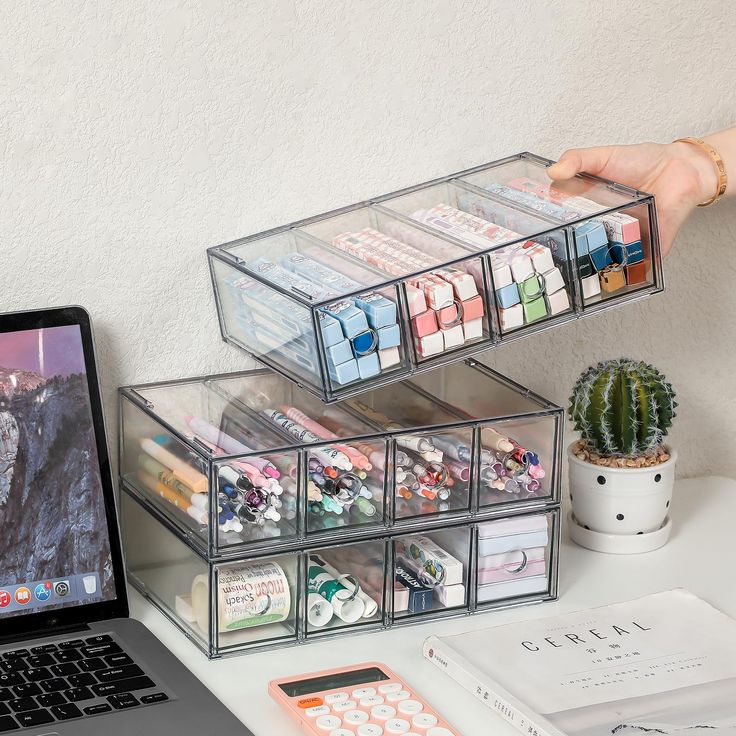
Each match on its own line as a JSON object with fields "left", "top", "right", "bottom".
{"left": 0, "top": 0, "right": 736, "bottom": 475}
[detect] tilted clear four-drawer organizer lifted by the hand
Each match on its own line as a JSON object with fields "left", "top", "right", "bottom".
{"left": 208, "top": 153, "right": 664, "bottom": 402}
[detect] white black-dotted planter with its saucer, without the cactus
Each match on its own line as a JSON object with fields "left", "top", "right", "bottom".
{"left": 567, "top": 445, "right": 677, "bottom": 554}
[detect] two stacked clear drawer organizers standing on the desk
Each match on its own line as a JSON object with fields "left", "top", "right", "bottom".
{"left": 120, "top": 359, "right": 563, "bottom": 657}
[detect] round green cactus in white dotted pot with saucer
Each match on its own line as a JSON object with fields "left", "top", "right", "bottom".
{"left": 568, "top": 358, "right": 677, "bottom": 553}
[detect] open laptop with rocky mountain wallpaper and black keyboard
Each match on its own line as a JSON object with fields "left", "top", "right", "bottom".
{"left": 0, "top": 307, "right": 252, "bottom": 736}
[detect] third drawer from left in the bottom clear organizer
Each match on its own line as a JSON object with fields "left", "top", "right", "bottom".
{"left": 392, "top": 526, "right": 473, "bottom": 621}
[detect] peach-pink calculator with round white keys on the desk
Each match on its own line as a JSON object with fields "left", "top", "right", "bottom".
{"left": 268, "top": 662, "right": 459, "bottom": 736}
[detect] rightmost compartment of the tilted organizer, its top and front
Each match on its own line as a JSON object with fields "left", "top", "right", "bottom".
{"left": 462, "top": 154, "right": 662, "bottom": 311}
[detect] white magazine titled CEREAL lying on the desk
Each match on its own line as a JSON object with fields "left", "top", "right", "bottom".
{"left": 424, "top": 590, "right": 736, "bottom": 736}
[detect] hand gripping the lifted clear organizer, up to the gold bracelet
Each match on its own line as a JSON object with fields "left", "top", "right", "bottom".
{"left": 547, "top": 143, "right": 718, "bottom": 255}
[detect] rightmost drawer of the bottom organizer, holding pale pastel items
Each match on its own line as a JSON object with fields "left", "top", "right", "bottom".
{"left": 476, "top": 511, "right": 559, "bottom": 608}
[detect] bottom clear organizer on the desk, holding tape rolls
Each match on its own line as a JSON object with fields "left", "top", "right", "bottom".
{"left": 120, "top": 489, "right": 559, "bottom": 658}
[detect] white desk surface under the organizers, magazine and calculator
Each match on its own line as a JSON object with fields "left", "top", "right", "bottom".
{"left": 131, "top": 478, "right": 736, "bottom": 736}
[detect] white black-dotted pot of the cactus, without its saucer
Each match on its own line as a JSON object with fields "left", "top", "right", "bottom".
{"left": 567, "top": 443, "right": 677, "bottom": 535}
